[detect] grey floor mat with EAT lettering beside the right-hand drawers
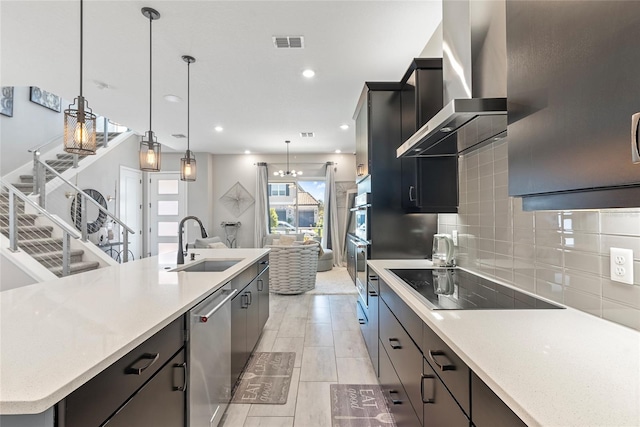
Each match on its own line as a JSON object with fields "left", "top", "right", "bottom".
{"left": 331, "top": 384, "right": 396, "bottom": 427}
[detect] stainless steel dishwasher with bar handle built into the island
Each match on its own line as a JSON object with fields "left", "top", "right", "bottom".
{"left": 187, "top": 283, "right": 238, "bottom": 427}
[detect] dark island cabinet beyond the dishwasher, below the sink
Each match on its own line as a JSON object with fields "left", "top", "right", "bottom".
{"left": 231, "top": 256, "right": 269, "bottom": 386}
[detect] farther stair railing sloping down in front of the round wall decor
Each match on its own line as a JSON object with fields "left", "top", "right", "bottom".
{"left": 34, "top": 157, "right": 135, "bottom": 262}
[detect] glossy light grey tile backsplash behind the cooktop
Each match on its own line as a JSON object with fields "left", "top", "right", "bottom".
{"left": 438, "top": 139, "right": 640, "bottom": 330}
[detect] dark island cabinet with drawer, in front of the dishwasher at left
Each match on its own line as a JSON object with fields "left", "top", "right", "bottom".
{"left": 56, "top": 317, "right": 186, "bottom": 427}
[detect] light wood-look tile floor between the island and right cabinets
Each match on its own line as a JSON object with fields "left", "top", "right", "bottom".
{"left": 221, "top": 294, "right": 378, "bottom": 427}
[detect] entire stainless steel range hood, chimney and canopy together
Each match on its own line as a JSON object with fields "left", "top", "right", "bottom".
{"left": 396, "top": 0, "right": 507, "bottom": 157}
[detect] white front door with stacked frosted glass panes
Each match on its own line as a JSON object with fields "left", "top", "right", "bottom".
{"left": 149, "top": 172, "right": 187, "bottom": 256}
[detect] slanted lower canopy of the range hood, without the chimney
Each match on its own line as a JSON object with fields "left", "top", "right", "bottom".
{"left": 396, "top": 98, "right": 507, "bottom": 157}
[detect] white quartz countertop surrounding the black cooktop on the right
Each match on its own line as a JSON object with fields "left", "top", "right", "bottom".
{"left": 369, "top": 260, "right": 640, "bottom": 427}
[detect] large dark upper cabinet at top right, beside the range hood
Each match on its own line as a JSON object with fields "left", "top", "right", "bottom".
{"left": 506, "top": 0, "right": 640, "bottom": 210}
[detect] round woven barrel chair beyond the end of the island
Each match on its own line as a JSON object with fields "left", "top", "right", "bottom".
{"left": 266, "top": 245, "right": 320, "bottom": 294}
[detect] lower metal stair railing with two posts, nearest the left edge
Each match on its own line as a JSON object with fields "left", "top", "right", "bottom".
{"left": 0, "top": 177, "right": 81, "bottom": 276}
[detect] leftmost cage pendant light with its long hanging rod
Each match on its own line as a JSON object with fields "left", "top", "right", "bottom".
{"left": 64, "top": 0, "right": 96, "bottom": 156}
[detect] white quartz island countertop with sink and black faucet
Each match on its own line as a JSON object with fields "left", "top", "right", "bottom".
{"left": 0, "top": 249, "right": 269, "bottom": 415}
